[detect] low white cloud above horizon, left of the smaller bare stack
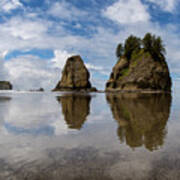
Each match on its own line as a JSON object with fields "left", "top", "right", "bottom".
{"left": 4, "top": 56, "right": 60, "bottom": 90}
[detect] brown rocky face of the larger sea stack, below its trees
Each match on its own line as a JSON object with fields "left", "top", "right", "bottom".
{"left": 106, "top": 52, "right": 171, "bottom": 91}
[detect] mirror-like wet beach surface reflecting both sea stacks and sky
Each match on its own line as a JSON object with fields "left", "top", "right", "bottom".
{"left": 0, "top": 91, "right": 180, "bottom": 180}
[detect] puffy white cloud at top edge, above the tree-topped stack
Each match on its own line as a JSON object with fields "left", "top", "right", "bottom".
{"left": 103, "top": 0, "right": 150, "bottom": 24}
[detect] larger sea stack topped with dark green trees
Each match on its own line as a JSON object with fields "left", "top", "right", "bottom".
{"left": 106, "top": 34, "right": 171, "bottom": 92}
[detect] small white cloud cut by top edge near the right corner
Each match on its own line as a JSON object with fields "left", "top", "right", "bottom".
{"left": 146, "top": 0, "right": 177, "bottom": 12}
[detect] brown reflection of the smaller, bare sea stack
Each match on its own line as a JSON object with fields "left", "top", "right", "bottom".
{"left": 57, "top": 94, "right": 91, "bottom": 129}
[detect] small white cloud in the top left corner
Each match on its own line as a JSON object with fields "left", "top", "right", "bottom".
{"left": 0, "top": 0, "right": 23, "bottom": 12}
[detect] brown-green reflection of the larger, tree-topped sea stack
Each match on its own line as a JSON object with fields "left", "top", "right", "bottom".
{"left": 107, "top": 94, "right": 171, "bottom": 151}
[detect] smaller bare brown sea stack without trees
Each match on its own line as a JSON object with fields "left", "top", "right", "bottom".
{"left": 54, "top": 56, "right": 96, "bottom": 91}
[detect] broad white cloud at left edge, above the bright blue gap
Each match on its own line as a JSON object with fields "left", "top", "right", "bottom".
{"left": 0, "top": 16, "right": 52, "bottom": 51}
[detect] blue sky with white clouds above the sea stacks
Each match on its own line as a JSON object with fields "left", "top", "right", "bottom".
{"left": 0, "top": 0, "right": 180, "bottom": 90}
